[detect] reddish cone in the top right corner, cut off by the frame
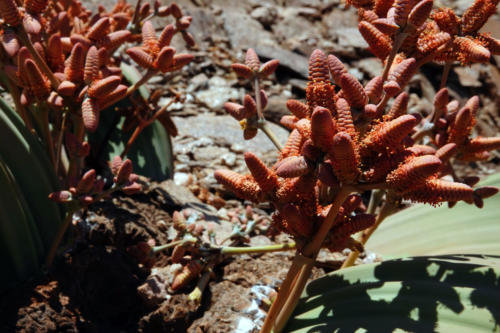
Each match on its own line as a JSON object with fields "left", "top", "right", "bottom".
{"left": 461, "top": 0, "right": 498, "bottom": 36}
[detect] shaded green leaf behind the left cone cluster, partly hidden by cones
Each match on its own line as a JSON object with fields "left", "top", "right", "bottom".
{"left": 89, "top": 63, "right": 174, "bottom": 181}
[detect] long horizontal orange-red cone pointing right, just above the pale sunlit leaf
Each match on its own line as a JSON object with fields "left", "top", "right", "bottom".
{"left": 403, "top": 179, "right": 474, "bottom": 205}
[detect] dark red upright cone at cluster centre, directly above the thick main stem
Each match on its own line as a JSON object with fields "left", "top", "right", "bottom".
{"left": 329, "top": 132, "right": 360, "bottom": 183}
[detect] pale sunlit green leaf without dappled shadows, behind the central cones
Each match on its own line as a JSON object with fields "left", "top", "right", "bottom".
{"left": 366, "top": 174, "right": 500, "bottom": 257}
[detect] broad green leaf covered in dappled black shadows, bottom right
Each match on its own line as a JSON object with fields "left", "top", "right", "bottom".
{"left": 284, "top": 255, "right": 500, "bottom": 333}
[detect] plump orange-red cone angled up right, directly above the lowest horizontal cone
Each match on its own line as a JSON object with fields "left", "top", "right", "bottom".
{"left": 386, "top": 155, "right": 441, "bottom": 193}
